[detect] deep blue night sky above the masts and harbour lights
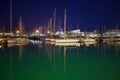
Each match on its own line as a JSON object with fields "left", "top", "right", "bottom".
{"left": 0, "top": 0, "right": 120, "bottom": 31}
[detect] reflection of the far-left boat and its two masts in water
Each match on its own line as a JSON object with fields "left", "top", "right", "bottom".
{"left": 7, "top": 44, "right": 27, "bottom": 80}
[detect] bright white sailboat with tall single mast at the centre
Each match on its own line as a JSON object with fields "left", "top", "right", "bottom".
{"left": 54, "top": 9, "right": 80, "bottom": 43}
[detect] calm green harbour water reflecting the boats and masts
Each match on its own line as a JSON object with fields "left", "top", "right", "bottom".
{"left": 0, "top": 43, "right": 120, "bottom": 80}
